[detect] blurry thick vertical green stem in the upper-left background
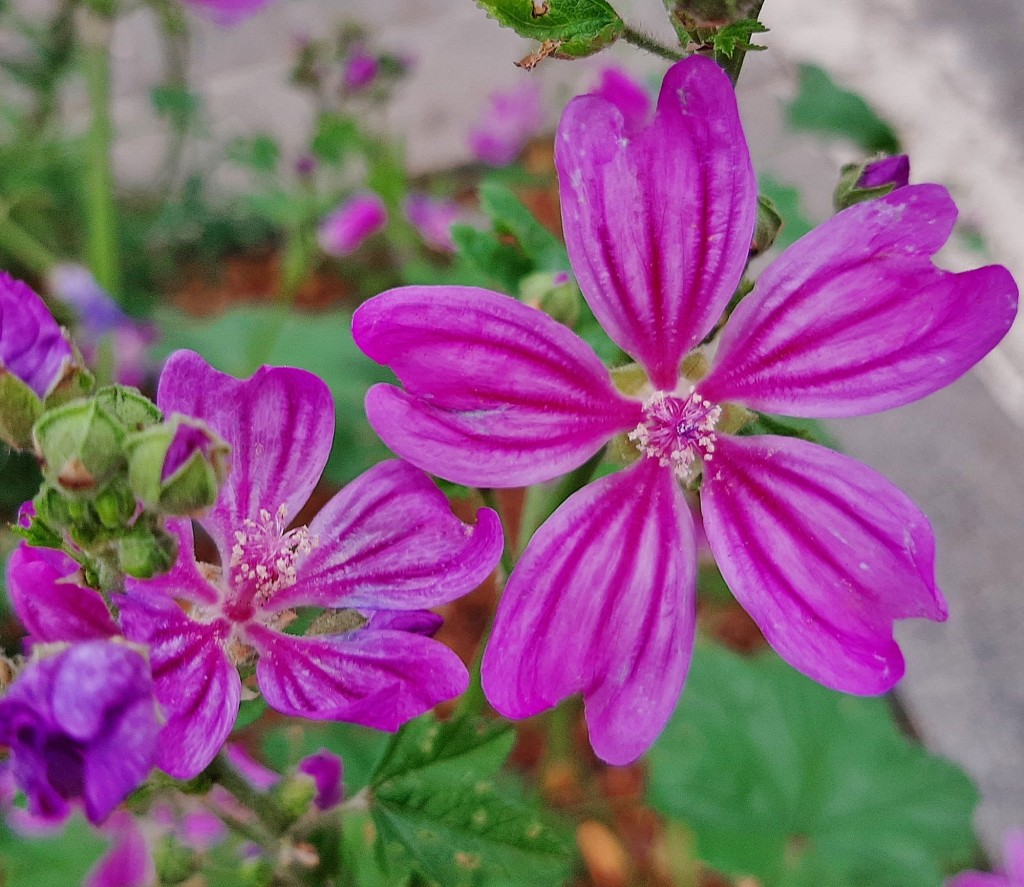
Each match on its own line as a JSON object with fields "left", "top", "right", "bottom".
{"left": 78, "top": 6, "right": 121, "bottom": 297}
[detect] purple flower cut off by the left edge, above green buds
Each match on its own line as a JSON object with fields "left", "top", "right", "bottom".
{"left": 0, "top": 271, "right": 74, "bottom": 399}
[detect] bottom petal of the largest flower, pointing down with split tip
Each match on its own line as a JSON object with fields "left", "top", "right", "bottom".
{"left": 481, "top": 459, "right": 696, "bottom": 764}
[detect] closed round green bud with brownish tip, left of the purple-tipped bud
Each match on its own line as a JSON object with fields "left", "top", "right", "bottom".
{"left": 32, "top": 400, "right": 125, "bottom": 496}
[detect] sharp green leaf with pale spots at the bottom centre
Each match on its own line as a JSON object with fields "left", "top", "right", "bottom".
{"left": 371, "top": 715, "right": 572, "bottom": 887}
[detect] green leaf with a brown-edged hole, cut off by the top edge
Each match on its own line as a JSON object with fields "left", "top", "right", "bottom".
{"left": 476, "top": 0, "right": 626, "bottom": 57}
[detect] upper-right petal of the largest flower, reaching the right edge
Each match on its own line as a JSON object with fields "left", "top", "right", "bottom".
{"left": 700, "top": 185, "right": 1017, "bottom": 417}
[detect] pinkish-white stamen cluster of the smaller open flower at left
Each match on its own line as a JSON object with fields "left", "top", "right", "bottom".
{"left": 229, "top": 505, "right": 319, "bottom": 604}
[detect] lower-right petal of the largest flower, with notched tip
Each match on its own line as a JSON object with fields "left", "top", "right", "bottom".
{"left": 700, "top": 434, "right": 946, "bottom": 694}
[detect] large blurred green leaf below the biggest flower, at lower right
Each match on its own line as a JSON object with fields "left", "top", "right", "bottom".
{"left": 649, "top": 644, "right": 978, "bottom": 887}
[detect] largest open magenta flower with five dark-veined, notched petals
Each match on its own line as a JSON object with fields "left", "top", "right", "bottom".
{"left": 353, "top": 57, "right": 1017, "bottom": 763}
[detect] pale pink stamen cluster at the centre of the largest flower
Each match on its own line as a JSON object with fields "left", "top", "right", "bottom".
{"left": 628, "top": 388, "right": 722, "bottom": 481}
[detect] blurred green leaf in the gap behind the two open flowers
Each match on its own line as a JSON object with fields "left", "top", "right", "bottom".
{"left": 155, "top": 306, "right": 393, "bottom": 483}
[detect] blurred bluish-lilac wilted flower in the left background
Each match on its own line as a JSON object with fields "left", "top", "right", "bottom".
{"left": 49, "top": 263, "right": 157, "bottom": 387}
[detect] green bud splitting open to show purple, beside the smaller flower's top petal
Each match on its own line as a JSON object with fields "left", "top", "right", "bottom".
{"left": 125, "top": 415, "right": 230, "bottom": 515}
